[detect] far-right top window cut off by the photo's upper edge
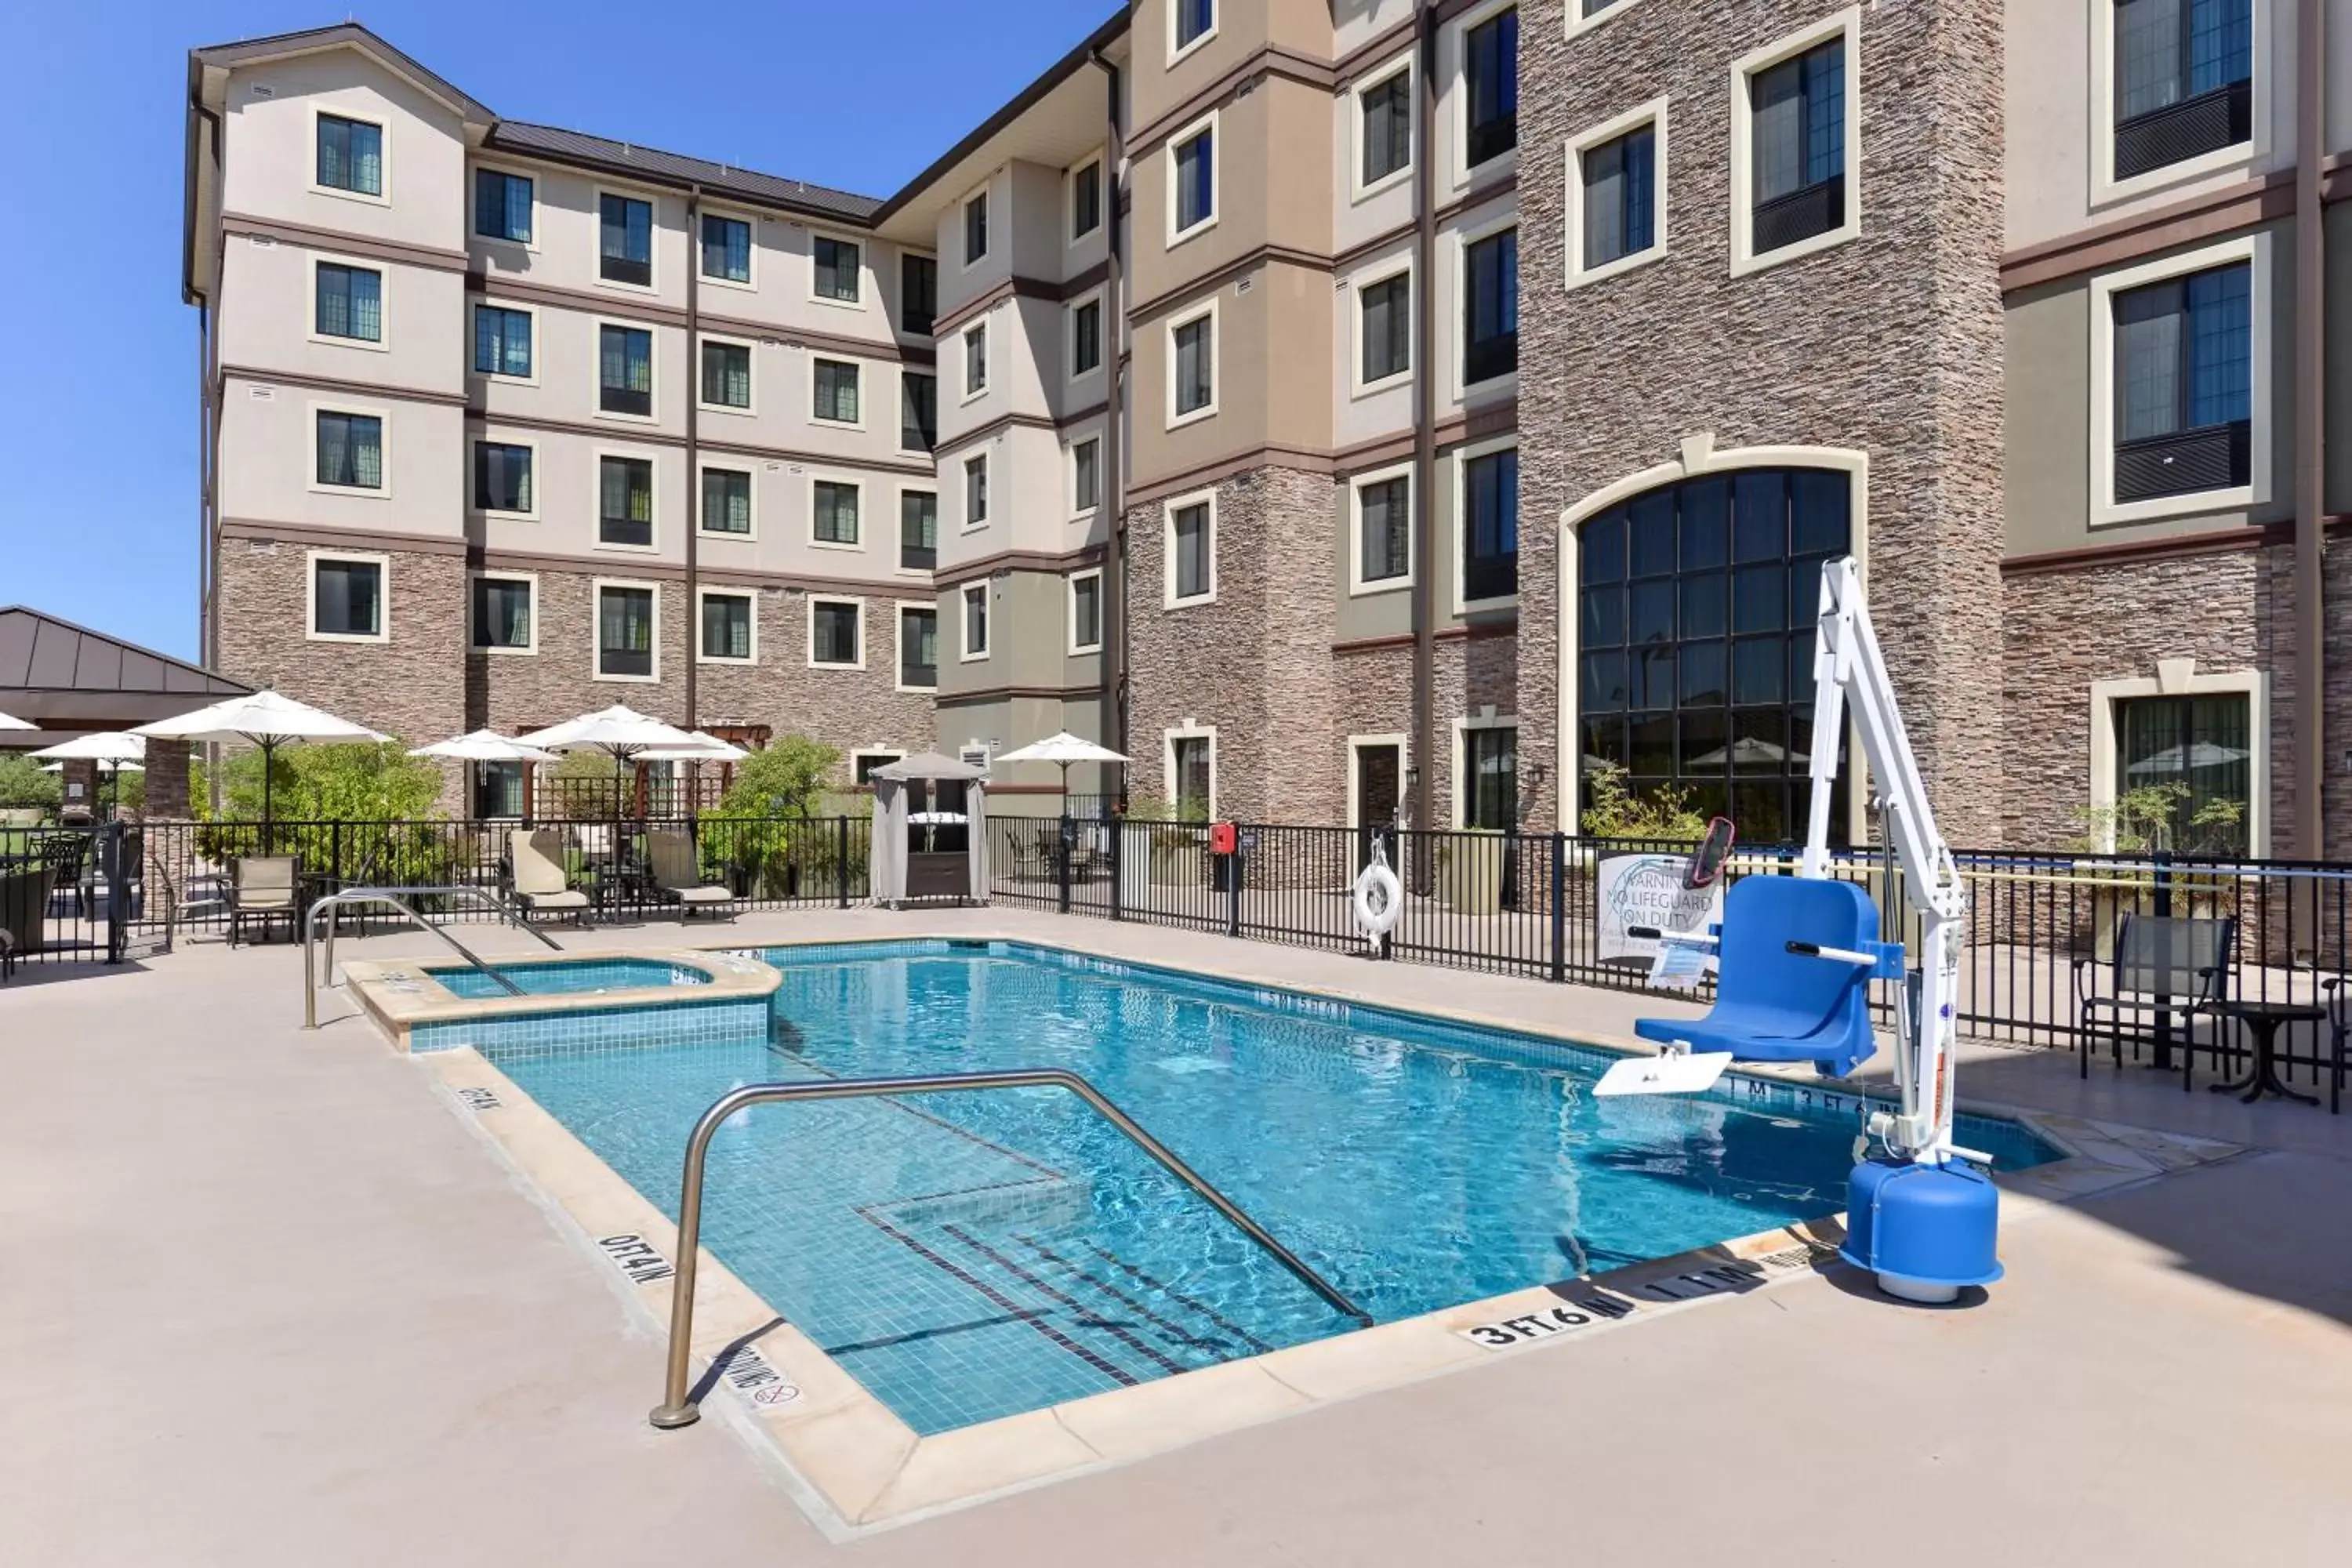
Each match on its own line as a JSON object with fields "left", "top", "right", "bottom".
{"left": 2114, "top": 0, "right": 2253, "bottom": 181}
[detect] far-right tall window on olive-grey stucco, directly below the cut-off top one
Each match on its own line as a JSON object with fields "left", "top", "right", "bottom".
{"left": 2110, "top": 261, "right": 2253, "bottom": 503}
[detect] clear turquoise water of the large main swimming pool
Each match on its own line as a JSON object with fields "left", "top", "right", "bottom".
{"left": 480, "top": 942, "right": 2056, "bottom": 1434}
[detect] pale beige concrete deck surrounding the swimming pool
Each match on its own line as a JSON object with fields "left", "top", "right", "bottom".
{"left": 0, "top": 909, "right": 2352, "bottom": 1568}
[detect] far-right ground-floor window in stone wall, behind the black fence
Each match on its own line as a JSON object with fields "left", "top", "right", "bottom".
{"left": 2114, "top": 694, "right": 2253, "bottom": 855}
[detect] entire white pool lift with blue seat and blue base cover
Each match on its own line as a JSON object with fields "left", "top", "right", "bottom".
{"left": 1595, "top": 557, "right": 2002, "bottom": 1302}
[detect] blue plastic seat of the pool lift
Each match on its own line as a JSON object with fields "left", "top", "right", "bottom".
{"left": 1632, "top": 877, "right": 1900, "bottom": 1076}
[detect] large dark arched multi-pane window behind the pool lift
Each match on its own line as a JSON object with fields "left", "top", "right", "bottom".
{"left": 1576, "top": 468, "right": 1853, "bottom": 844}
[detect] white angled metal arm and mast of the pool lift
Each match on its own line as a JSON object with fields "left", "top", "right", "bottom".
{"left": 1797, "top": 555, "right": 1983, "bottom": 1163}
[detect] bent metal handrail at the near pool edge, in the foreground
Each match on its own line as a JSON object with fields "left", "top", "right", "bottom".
{"left": 647, "top": 1067, "right": 1371, "bottom": 1432}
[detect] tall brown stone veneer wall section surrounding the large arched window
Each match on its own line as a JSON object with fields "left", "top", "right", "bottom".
{"left": 1517, "top": 0, "right": 2004, "bottom": 844}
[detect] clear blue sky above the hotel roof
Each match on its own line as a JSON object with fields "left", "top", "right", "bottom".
{"left": 0, "top": 0, "right": 1117, "bottom": 659}
